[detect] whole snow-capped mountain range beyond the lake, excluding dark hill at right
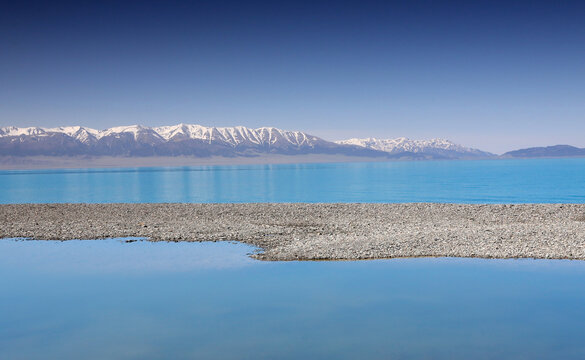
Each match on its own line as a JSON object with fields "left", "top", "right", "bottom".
{"left": 0, "top": 124, "right": 494, "bottom": 159}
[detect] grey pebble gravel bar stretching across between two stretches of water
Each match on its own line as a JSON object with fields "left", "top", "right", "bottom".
{"left": 0, "top": 203, "right": 585, "bottom": 260}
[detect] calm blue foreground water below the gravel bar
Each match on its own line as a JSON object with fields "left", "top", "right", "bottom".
{"left": 0, "top": 240, "right": 585, "bottom": 360}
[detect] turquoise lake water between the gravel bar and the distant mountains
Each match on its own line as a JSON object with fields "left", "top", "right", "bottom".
{"left": 0, "top": 158, "right": 585, "bottom": 203}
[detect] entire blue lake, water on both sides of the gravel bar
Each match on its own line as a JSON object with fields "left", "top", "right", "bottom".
{"left": 0, "top": 159, "right": 585, "bottom": 359}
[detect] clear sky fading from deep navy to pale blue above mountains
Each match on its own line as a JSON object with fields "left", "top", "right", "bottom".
{"left": 0, "top": 0, "right": 585, "bottom": 153}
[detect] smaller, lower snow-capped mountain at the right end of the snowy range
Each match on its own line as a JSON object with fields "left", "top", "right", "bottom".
{"left": 335, "top": 137, "right": 494, "bottom": 158}
